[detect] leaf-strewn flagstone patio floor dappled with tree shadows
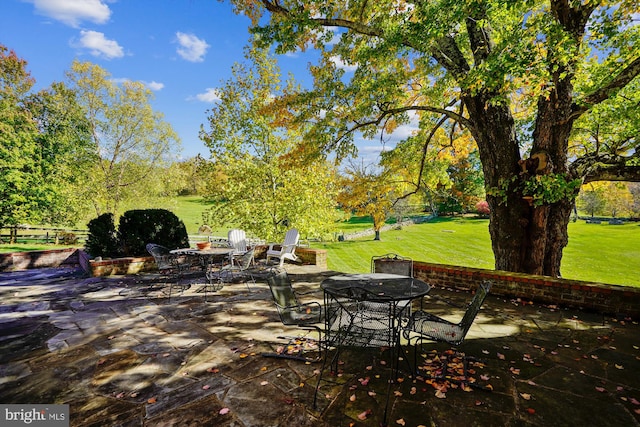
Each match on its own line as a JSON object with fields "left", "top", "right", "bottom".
{"left": 0, "top": 264, "right": 640, "bottom": 427}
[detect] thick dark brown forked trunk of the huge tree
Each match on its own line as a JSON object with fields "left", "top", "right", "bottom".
{"left": 464, "top": 87, "right": 573, "bottom": 277}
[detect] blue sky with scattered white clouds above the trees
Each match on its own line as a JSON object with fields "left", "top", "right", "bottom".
{"left": 0, "top": 0, "right": 409, "bottom": 163}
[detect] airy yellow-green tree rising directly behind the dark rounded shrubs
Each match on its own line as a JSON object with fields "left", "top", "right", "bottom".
{"left": 67, "top": 61, "right": 179, "bottom": 215}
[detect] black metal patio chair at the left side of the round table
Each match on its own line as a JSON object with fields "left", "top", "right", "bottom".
{"left": 262, "top": 269, "right": 324, "bottom": 361}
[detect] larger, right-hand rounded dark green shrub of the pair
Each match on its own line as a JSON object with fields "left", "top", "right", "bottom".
{"left": 118, "top": 209, "right": 189, "bottom": 256}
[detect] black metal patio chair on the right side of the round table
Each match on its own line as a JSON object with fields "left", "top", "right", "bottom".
{"left": 403, "top": 281, "right": 492, "bottom": 385}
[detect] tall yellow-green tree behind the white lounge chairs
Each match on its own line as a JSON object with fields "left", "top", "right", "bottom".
{"left": 200, "top": 49, "right": 336, "bottom": 241}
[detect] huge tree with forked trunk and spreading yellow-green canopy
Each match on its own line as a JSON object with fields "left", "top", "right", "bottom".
{"left": 231, "top": 0, "right": 640, "bottom": 276}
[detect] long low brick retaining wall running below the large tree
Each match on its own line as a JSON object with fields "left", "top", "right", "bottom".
{"left": 413, "top": 261, "right": 640, "bottom": 319}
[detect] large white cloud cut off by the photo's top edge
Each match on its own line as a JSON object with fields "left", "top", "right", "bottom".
{"left": 27, "top": 0, "right": 111, "bottom": 28}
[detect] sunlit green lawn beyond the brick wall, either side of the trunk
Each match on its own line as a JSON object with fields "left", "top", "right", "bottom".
{"left": 314, "top": 218, "right": 640, "bottom": 286}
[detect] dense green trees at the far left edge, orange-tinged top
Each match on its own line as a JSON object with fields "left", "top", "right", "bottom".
{"left": 0, "top": 45, "right": 89, "bottom": 229}
